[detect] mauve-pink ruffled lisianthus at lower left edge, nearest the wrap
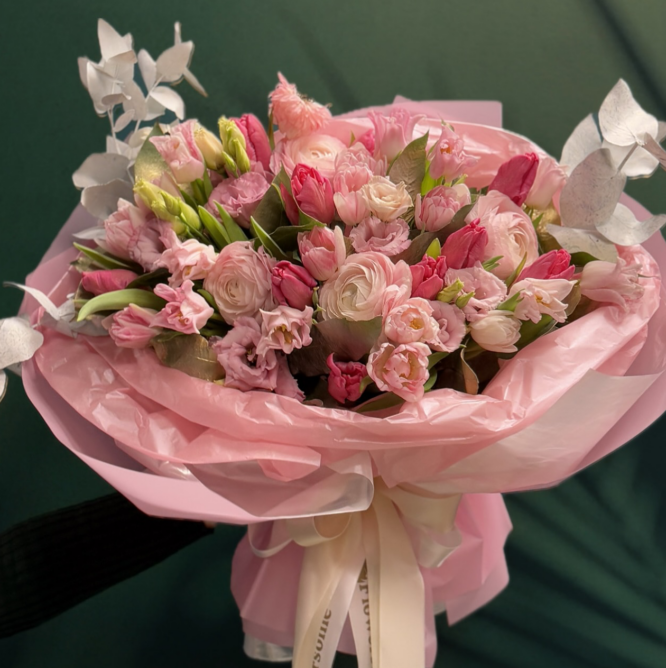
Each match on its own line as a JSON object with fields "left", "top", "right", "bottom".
{"left": 210, "top": 316, "right": 278, "bottom": 392}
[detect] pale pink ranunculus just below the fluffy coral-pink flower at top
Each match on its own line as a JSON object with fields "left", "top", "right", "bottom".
{"left": 271, "top": 133, "right": 347, "bottom": 179}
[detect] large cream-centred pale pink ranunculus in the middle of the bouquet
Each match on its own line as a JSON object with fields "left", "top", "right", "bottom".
{"left": 319, "top": 253, "right": 412, "bottom": 320}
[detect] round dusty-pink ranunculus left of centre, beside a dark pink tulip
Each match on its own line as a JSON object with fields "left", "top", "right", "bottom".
{"left": 204, "top": 241, "right": 275, "bottom": 325}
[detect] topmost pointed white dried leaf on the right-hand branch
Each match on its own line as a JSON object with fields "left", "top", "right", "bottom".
{"left": 599, "top": 79, "right": 659, "bottom": 146}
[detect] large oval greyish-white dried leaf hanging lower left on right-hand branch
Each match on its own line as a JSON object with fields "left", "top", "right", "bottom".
{"left": 560, "top": 148, "right": 627, "bottom": 230}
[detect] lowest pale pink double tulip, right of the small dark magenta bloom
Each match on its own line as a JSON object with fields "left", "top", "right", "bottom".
{"left": 367, "top": 343, "right": 430, "bottom": 401}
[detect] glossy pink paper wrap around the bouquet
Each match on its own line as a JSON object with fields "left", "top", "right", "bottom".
{"left": 18, "top": 100, "right": 666, "bottom": 664}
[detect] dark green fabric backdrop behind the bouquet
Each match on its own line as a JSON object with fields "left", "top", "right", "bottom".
{"left": 0, "top": 0, "right": 666, "bottom": 668}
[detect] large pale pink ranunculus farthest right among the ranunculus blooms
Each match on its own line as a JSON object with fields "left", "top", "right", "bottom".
{"left": 466, "top": 190, "right": 539, "bottom": 279}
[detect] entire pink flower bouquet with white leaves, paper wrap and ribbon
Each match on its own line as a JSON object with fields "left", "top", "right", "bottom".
{"left": 0, "top": 21, "right": 666, "bottom": 668}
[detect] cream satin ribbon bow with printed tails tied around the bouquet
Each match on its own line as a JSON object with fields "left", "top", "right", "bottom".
{"left": 249, "top": 479, "right": 460, "bottom": 668}
